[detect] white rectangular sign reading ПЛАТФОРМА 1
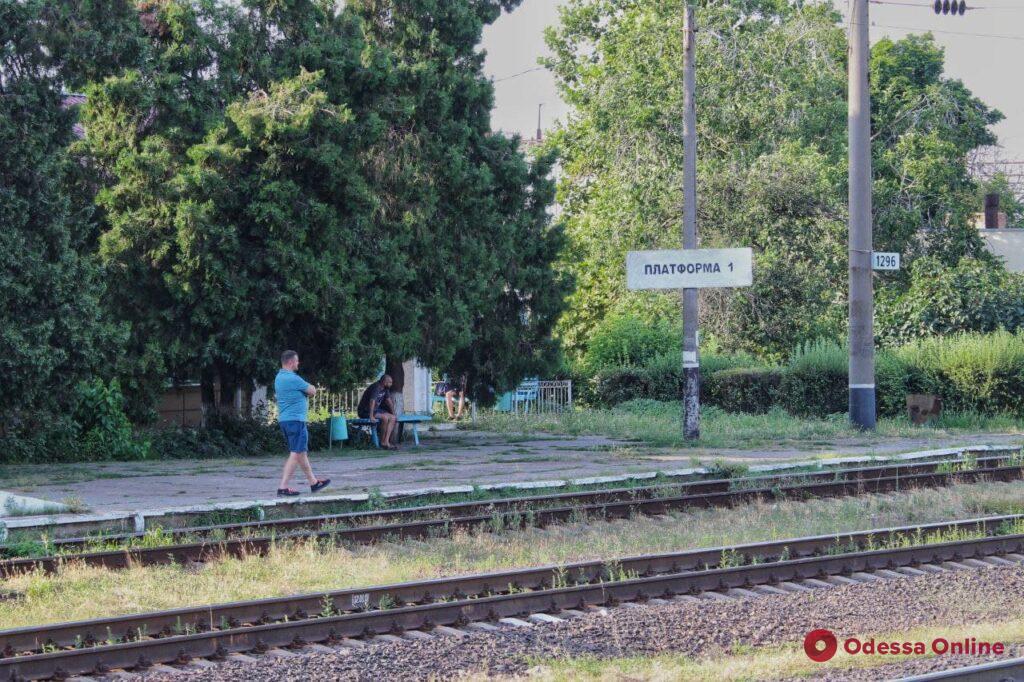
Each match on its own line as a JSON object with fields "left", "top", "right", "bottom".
{"left": 626, "top": 249, "right": 754, "bottom": 289}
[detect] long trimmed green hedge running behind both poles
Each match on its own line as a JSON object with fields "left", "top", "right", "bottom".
{"left": 577, "top": 332, "right": 1024, "bottom": 417}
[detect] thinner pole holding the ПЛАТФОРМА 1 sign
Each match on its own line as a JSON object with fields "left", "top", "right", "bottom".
{"left": 682, "top": 0, "right": 700, "bottom": 440}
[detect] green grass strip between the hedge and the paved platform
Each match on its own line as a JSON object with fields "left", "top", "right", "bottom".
{"left": 476, "top": 400, "right": 1024, "bottom": 449}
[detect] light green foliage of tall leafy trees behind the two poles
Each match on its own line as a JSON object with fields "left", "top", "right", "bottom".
{"left": 548, "top": 0, "right": 1001, "bottom": 360}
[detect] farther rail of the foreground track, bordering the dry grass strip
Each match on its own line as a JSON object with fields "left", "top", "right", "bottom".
{"left": 0, "top": 514, "right": 1024, "bottom": 656}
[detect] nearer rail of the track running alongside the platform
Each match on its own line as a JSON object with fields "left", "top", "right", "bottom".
{"left": 0, "top": 458, "right": 1024, "bottom": 577}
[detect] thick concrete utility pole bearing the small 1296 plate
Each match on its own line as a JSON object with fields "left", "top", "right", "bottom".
{"left": 848, "top": 0, "right": 874, "bottom": 429}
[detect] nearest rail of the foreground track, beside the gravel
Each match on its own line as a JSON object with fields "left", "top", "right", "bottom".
{"left": 0, "top": 534, "right": 1024, "bottom": 679}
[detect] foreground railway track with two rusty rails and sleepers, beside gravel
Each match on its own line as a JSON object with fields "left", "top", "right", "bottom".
{"left": 0, "top": 515, "right": 1024, "bottom": 680}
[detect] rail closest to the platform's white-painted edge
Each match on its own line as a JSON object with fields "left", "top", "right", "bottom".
{"left": 16, "top": 453, "right": 1014, "bottom": 549}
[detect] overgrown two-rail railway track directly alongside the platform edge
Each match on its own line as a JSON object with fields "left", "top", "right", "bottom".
{"left": 0, "top": 455, "right": 1024, "bottom": 577}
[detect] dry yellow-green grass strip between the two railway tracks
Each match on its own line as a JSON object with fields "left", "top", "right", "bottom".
{"left": 0, "top": 481, "right": 1024, "bottom": 628}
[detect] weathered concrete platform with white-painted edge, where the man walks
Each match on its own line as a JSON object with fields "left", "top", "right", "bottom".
{"left": 0, "top": 431, "right": 1022, "bottom": 520}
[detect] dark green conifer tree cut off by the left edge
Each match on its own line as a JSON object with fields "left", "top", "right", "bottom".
{"left": 0, "top": 0, "right": 122, "bottom": 439}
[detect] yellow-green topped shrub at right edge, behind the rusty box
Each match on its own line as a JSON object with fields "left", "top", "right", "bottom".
{"left": 897, "top": 332, "right": 1024, "bottom": 415}
